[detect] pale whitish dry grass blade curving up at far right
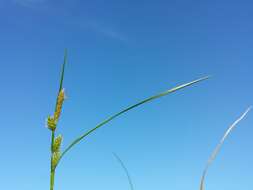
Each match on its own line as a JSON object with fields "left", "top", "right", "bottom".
{"left": 200, "top": 107, "right": 251, "bottom": 190}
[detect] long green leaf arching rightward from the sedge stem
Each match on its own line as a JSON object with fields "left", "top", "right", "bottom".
{"left": 60, "top": 76, "right": 209, "bottom": 163}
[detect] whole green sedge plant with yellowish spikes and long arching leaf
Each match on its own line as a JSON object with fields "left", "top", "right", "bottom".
{"left": 47, "top": 50, "right": 209, "bottom": 190}
